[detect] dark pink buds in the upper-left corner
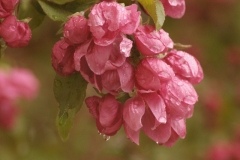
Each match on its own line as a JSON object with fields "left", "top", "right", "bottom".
{"left": 0, "top": 0, "right": 32, "bottom": 48}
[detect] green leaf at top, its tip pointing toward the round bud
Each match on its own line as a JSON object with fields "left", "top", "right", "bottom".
{"left": 38, "top": 0, "right": 73, "bottom": 22}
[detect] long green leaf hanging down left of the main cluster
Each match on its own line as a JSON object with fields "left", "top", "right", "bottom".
{"left": 53, "top": 73, "right": 87, "bottom": 141}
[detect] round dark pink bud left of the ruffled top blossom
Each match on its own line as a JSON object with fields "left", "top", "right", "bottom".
{"left": 63, "top": 15, "right": 90, "bottom": 44}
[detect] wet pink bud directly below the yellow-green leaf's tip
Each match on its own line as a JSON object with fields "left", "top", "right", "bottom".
{"left": 134, "top": 25, "right": 173, "bottom": 55}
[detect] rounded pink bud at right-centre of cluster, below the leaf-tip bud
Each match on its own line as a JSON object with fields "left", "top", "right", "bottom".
{"left": 135, "top": 58, "right": 175, "bottom": 91}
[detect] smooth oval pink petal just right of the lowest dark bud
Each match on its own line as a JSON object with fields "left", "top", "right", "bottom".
{"left": 123, "top": 96, "right": 145, "bottom": 131}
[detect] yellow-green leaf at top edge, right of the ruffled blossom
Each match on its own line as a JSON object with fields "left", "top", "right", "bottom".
{"left": 138, "top": 0, "right": 165, "bottom": 30}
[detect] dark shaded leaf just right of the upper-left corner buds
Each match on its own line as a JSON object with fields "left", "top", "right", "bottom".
{"left": 18, "top": 1, "right": 45, "bottom": 29}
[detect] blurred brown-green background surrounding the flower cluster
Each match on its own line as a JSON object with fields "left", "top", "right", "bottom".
{"left": 0, "top": 0, "right": 240, "bottom": 160}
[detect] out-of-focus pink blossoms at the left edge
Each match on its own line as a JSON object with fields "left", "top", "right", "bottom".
{"left": 0, "top": 69, "right": 39, "bottom": 129}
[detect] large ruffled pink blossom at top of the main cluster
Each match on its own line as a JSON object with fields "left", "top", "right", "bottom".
{"left": 88, "top": 1, "right": 140, "bottom": 46}
